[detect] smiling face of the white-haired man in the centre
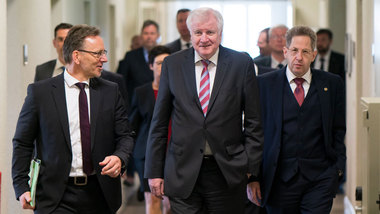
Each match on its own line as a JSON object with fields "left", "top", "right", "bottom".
{"left": 190, "top": 13, "right": 222, "bottom": 59}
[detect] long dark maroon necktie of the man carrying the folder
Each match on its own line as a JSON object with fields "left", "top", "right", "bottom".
{"left": 75, "top": 83, "right": 94, "bottom": 175}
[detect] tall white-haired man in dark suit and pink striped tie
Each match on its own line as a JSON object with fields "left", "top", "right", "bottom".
{"left": 145, "top": 8, "right": 263, "bottom": 214}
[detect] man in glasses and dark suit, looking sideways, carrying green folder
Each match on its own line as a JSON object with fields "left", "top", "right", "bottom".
{"left": 12, "top": 25, "right": 133, "bottom": 213}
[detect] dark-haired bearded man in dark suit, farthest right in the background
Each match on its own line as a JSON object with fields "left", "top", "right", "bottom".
{"left": 311, "top": 29, "right": 346, "bottom": 80}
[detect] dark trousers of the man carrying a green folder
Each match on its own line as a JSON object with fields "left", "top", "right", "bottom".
{"left": 53, "top": 175, "right": 113, "bottom": 214}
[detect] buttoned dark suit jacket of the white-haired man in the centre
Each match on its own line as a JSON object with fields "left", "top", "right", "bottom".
{"left": 145, "top": 46, "right": 263, "bottom": 198}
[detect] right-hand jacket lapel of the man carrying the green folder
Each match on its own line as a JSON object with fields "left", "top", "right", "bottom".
{"left": 90, "top": 78, "right": 101, "bottom": 149}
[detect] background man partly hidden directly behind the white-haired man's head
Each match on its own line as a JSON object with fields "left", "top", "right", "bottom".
{"left": 166, "top": 9, "right": 191, "bottom": 53}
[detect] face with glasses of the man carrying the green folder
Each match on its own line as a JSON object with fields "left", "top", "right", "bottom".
{"left": 73, "top": 36, "right": 108, "bottom": 79}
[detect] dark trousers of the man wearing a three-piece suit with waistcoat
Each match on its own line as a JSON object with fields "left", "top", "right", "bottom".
{"left": 265, "top": 167, "right": 338, "bottom": 214}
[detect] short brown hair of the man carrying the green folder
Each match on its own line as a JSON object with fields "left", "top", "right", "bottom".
{"left": 63, "top": 25, "right": 100, "bottom": 63}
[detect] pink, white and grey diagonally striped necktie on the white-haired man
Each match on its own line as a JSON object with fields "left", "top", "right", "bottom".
{"left": 199, "top": 60, "right": 210, "bottom": 117}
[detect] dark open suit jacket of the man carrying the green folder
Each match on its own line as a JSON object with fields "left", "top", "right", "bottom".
{"left": 12, "top": 74, "right": 133, "bottom": 213}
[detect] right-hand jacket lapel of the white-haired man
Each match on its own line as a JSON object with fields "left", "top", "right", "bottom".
{"left": 206, "top": 46, "right": 227, "bottom": 117}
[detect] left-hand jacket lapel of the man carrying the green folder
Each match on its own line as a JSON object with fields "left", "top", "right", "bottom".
{"left": 52, "top": 73, "right": 71, "bottom": 150}
